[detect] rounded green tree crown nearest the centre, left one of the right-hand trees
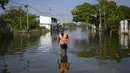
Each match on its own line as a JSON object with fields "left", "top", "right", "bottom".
{"left": 71, "top": 2, "right": 94, "bottom": 23}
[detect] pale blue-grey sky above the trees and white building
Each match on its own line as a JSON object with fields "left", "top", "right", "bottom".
{"left": 1, "top": 0, "right": 130, "bottom": 20}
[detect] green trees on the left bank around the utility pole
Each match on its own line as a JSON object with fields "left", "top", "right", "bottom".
{"left": 1, "top": 7, "right": 38, "bottom": 30}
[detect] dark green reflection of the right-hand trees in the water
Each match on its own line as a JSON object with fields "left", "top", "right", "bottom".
{"left": 75, "top": 32, "right": 130, "bottom": 62}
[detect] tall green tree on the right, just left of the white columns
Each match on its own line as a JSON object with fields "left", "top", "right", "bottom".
{"left": 104, "top": 2, "right": 124, "bottom": 30}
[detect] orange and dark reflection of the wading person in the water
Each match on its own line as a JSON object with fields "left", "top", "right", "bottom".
{"left": 58, "top": 54, "right": 70, "bottom": 73}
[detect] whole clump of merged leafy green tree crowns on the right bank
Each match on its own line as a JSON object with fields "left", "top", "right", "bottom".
{"left": 71, "top": 0, "right": 125, "bottom": 30}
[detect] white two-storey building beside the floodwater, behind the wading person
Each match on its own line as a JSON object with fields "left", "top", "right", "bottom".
{"left": 39, "top": 16, "right": 58, "bottom": 30}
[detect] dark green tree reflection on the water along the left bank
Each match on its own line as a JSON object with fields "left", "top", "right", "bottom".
{"left": 0, "top": 35, "right": 40, "bottom": 56}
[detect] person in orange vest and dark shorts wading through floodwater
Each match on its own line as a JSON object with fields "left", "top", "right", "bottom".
{"left": 58, "top": 30, "right": 69, "bottom": 54}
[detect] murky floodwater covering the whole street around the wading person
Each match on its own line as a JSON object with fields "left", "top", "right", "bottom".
{"left": 0, "top": 28, "right": 130, "bottom": 73}
